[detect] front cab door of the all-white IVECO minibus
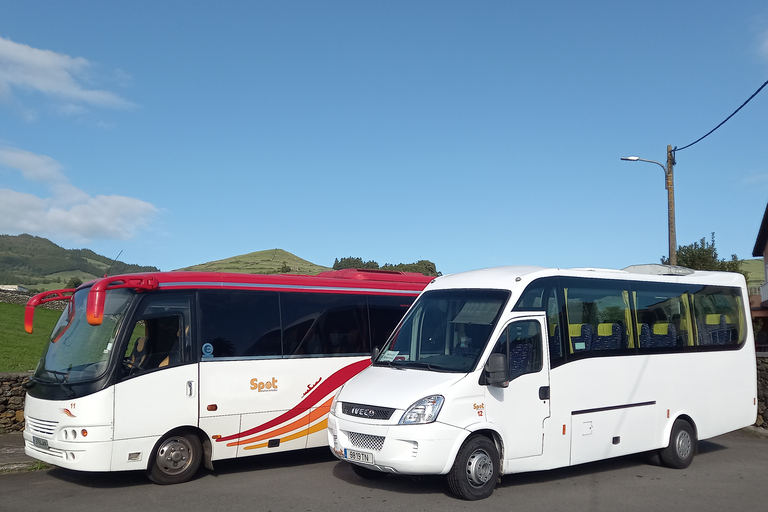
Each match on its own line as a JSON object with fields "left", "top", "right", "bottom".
{"left": 483, "top": 314, "right": 550, "bottom": 460}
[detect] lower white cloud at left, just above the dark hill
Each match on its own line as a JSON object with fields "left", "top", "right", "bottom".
{"left": 0, "top": 146, "right": 158, "bottom": 243}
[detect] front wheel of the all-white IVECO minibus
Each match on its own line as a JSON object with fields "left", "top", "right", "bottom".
{"left": 448, "top": 435, "right": 499, "bottom": 501}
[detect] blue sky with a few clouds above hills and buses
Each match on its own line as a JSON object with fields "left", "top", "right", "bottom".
{"left": 0, "top": 0, "right": 768, "bottom": 274}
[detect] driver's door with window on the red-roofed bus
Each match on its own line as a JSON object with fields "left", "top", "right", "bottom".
{"left": 114, "top": 293, "right": 198, "bottom": 456}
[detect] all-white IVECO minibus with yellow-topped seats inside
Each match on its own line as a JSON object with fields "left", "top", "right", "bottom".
{"left": 328, "top": 265, "right": 757, "bottom": 500}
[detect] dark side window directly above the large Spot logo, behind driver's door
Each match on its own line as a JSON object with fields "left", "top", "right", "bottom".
{"left": 199, "top": 290, "right": 282, "bottom": 357}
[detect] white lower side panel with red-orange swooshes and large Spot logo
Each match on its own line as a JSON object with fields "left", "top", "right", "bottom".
{"left": 200, "top": 356, "right": 370, "bottom": 460}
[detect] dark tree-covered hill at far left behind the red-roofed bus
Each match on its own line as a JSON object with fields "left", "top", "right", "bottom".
{"left": 0, "top": 234, "right": 157, "bottom": 290}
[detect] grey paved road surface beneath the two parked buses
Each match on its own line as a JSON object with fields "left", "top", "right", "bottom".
{"left": 0, "top": 431, "right": 768, "bottom": 512}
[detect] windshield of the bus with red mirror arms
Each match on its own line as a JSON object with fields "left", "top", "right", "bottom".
{"left": 35, "top": 288, "right": 135, "bottom": 384}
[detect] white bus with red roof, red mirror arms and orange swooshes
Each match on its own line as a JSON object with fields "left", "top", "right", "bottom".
{"left": 24, "top": 269, "right": 432, "bottom": 484}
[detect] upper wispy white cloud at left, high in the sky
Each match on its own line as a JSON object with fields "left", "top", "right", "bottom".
{"left": 0, "top": 37, "right": 134, "bottom": 114}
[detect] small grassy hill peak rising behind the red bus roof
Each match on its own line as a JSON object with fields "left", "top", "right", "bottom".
{"left": 179, "top": 249, "right": 331, "bottom": 275}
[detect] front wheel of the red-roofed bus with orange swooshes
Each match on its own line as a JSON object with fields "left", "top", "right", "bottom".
{"left": 147, "top": 432, "right": 203, "bottom": 485}
